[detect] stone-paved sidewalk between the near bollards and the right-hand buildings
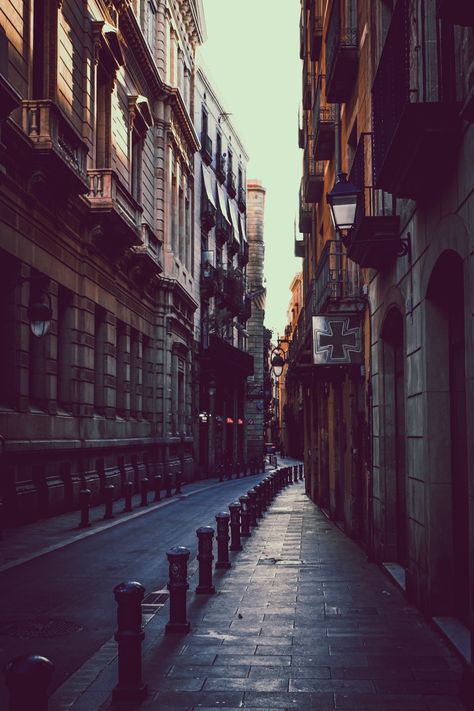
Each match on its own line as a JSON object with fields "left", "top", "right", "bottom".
{"left": 50, "top": 483, "right": 464, "bottom": 711}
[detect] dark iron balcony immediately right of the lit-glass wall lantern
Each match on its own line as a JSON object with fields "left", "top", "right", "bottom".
{"left": 345, "top": 133, "right": 404, "bottom": 271}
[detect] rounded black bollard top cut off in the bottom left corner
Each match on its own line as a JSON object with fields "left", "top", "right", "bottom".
{"left": 3, "top": 654, "right": 54, "bottom": 711}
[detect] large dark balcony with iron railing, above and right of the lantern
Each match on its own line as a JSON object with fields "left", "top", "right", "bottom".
{"left": 372, "top": 0, "right": 460, "bottom": 200}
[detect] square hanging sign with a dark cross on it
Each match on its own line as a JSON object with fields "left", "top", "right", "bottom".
{"left": 313, "top": 314, "right": 363, "bottom": 365}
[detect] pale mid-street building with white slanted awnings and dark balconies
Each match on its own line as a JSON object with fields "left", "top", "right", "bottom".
{"left": 195, "top": 69, "right": 253, "bottom": 475}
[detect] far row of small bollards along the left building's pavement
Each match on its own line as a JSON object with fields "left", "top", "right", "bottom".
{"left": 79, "top": 472, "right": 182, "bottom": 528}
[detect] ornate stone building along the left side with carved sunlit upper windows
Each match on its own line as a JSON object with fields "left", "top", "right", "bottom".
{"left": 0, "top": 0, "right": 204, "bottom": 521}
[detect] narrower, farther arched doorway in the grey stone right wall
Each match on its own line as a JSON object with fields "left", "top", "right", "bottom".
{"left": 382, "top": 308, "right": 408, "bottom": 568}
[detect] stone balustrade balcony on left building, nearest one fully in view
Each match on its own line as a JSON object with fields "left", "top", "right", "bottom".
{"left": 22, "top": 99, "right": 89, "bottom": 195}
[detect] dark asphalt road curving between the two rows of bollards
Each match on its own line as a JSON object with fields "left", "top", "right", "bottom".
{"left": 0, "top": 474, "right": 264, "bottom": 709}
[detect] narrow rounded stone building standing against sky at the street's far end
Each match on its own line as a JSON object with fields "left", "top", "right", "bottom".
{"left": 245, "top": 180, "right": 268, "bottom": 460}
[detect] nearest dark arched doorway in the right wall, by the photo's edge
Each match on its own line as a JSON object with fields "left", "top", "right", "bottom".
{"left": 426, "top": 250, "right": 469, "bottom": 623}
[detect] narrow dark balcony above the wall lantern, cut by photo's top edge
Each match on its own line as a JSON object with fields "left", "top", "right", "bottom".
{"left": 326, "top": 0, "right": 359, "bottom": 104}
